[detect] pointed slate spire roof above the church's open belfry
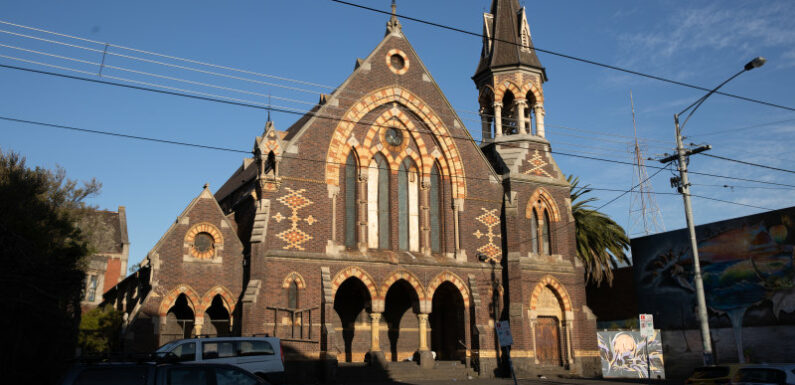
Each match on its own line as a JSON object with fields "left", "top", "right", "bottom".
{"left": 475, "top": 0, "right": 546, "bottom": 77}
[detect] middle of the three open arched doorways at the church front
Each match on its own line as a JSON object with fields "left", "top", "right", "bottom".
{"left": 384, "top": 279, "right": 420, "bottom": 361}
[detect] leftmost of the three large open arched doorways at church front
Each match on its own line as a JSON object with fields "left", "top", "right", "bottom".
{"left": 333, "top": 277, "right": 371, "bottom": 362}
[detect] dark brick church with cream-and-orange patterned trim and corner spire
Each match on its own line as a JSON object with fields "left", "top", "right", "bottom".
{"left": 105, "top": 0, "right": 600, "bottom": 375}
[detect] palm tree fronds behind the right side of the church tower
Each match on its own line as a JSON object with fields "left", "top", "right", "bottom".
{"left": 566, "top": 175, "right": 629, "bottom": 286}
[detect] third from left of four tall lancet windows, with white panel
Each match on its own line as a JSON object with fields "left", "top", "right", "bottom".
{"left": 398, "top": 158, "right": 420, "bottom": 251}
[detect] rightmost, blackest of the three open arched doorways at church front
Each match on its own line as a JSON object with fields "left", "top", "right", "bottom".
{"left": 429, "top": 281, "right": 466, "bottom": 360}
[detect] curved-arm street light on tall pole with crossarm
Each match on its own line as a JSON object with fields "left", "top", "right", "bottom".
{"left": 660, "top": 56, "right": 766, "bottom": 365}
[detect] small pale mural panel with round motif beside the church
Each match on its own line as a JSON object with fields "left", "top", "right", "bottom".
{"left": 596, "top": 330, "right": 665, "bottom": 379}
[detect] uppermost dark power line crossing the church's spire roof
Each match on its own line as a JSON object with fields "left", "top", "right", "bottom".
{"left": 331, "top": 0, "right": 795, "bottom": 111}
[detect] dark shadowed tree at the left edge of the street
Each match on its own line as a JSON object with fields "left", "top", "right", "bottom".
{"left": 0, "top": 151, "right": 100, "bottom": 384}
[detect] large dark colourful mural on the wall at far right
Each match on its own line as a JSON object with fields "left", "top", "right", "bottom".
{"left": 632, "top": 207, "right": 795, "bottom": 356}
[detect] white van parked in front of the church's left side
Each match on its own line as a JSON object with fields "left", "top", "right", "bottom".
{"left": 155, "top": 337, "right": 284, "bottom": 384}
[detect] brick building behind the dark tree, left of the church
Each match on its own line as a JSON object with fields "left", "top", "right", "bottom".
{"left": 78, "top": 206, "right": 130, "bottom": 311}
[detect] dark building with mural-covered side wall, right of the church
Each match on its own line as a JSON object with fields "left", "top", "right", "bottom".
{"left": 588, "top": 207, "right": 795, "bottom": 378}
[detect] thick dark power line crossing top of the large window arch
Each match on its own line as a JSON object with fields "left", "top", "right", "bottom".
{"left": 6, "top": 60, "right": 795, "bottom": 191}
